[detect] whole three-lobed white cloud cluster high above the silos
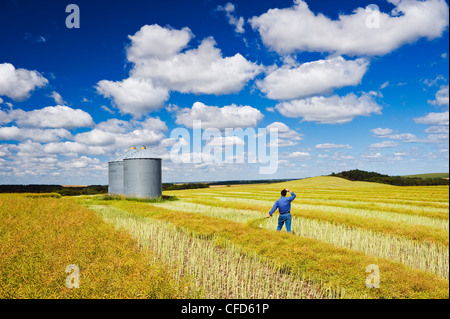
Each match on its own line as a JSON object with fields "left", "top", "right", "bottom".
{"left": 96, "top": 24, "right": 262, "bottom": 116}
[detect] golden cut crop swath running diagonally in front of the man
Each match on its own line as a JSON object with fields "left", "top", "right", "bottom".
{"left": 93, "top": 201, "right": 448, "bottom": 298}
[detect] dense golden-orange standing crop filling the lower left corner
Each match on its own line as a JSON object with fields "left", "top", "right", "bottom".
{"left": 0, "top": 194, "right": 190, "bottom": 299}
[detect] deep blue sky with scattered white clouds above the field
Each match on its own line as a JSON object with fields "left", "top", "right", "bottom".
{"left": 0, "top": 0, "right": 449, "bottom": 185}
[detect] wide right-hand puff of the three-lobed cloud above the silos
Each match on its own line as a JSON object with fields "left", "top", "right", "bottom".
{"left": 131, "top": 37, "right": 261, "bottom": 95}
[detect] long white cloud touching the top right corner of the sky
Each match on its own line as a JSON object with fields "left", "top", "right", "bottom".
{"left": 250, "top": 0, "right": 449, "bottom": 55}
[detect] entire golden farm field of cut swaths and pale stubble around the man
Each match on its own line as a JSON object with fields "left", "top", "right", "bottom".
{"left": 0, "top": 177, "right": 449, "bottom": 299}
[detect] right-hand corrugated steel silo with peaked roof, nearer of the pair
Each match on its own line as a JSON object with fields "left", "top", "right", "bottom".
{"left": 123, "top": 147, "right": 162, "bottom": 198}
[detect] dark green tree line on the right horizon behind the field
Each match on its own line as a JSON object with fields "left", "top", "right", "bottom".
{"left": 331, "top": 169, "right": 449, "bottom": 186}
